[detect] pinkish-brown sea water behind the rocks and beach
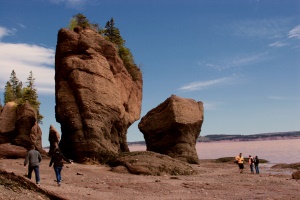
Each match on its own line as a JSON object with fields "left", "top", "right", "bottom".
{"left": 129, "top": 139, "right": 300, "bottom": 164}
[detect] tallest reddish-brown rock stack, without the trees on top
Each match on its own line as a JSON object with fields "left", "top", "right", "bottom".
{"left": 55, "top": 29, "right": 142, "bottom": 161}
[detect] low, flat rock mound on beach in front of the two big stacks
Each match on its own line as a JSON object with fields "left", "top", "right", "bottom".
{"left": 109, "top": 151, "right": 196, "bottom": 176}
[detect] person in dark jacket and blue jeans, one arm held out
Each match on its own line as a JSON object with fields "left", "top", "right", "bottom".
{"left": 49, "top": 148, "right": 73, "bottom": 186}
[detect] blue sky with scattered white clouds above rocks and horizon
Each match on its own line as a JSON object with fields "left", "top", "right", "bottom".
{"left": 0, "top": 0, "right": 300, "bottom": 146}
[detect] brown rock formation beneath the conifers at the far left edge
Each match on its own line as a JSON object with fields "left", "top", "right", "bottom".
{"left": 0, "top": 102, "right": 46, "bottom": 158}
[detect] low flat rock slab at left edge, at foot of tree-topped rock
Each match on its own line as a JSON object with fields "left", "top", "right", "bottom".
{"left": 0, "top": 143, "right": 27, "bottom": 159}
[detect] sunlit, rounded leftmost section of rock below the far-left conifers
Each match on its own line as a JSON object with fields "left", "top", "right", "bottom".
{"left": 0, "top": 102, "right": 17, "bottom": 144}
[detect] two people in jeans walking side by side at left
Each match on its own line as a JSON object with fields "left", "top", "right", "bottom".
{"left": 24, "top": 146, "right": 73, "bottom": 186}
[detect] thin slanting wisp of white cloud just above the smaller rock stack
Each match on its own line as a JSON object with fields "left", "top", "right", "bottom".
{"left": 178, "top": 77, "right": 232, "bottom": 92}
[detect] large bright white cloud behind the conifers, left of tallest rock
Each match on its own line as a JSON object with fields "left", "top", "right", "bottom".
{"left": 0, "top": 42, "right": 55, "bottom": 93}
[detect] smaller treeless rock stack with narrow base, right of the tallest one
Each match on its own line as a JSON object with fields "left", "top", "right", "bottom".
{"left": 138, "top": 95, "right": 203, "bottom": 163}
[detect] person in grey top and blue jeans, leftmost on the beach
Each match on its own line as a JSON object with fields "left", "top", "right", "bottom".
{"left": 24, "top": 145, "right": 42, "bottom": 186}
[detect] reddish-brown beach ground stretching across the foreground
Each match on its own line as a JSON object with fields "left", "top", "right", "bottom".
{"left": 0, "top": 159, "right": 300, "bottom": 200}
